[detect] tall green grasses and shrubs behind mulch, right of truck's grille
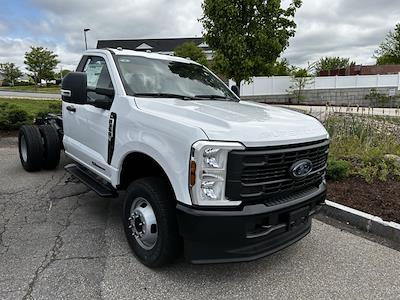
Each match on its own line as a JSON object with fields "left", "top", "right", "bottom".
{"left": 325, "top": 115, "right": 400, "bottom": 182}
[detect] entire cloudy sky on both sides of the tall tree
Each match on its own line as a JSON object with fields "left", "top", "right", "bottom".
{"left": 0, "top": 0, "right": 400, "bottom": 69}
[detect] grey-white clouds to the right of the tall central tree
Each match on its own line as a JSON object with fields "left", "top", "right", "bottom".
{"left": 283, "top": 0, "right": 400, "bottom": 66}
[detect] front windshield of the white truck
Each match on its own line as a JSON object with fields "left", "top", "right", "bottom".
{"left": 117, "top": 56, "right": 238, "bottom": 101}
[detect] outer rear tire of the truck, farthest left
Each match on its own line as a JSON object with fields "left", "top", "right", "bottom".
{"left": 18, "top": 125, "right": 44, "bottom": 172}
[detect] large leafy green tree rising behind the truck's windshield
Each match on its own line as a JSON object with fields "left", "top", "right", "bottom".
{"left": 200, "top": 0, "right": 301, "bottom": 91}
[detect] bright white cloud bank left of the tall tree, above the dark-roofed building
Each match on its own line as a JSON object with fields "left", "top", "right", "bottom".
{"left": 0, "top": 0, "right": 202, "bottom": 69}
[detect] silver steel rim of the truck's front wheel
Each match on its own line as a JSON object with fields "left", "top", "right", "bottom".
{"left": 128, "top": 197, "right": 158, "bottom": 250}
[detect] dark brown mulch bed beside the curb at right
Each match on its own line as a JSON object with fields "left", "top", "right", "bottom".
{"left": 327, "top": 177, "right": 400, "bottom": 223}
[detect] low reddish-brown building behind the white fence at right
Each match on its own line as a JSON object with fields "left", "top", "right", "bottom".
{"left": 319, "top": 65, "right": 400, "bottom": 76}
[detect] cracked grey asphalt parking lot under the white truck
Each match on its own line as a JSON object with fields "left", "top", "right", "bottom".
{"left": 0, "top": 138, "right": 400, "bottom": 299}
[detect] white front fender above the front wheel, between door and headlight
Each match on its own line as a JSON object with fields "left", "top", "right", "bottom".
{"left": 110, "top": 98, "right": 208, "bottom": 205}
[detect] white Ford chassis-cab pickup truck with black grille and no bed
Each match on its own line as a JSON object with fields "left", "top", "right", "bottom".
{"left": 19, "top": 48, "right": 329, "bottom": 267}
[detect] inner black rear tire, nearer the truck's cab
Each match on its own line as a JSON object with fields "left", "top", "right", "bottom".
{"left": 39, "top": 125, "right": 61, "bottom": 170}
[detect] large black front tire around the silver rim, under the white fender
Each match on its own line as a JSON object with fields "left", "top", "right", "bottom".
{"left": 123, "top": 177, "right": 181, "bottom": 268}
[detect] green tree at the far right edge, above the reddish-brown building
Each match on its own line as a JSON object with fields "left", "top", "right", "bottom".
{"left": 374, "top": 23, "right": 400, "bottom": 65}
